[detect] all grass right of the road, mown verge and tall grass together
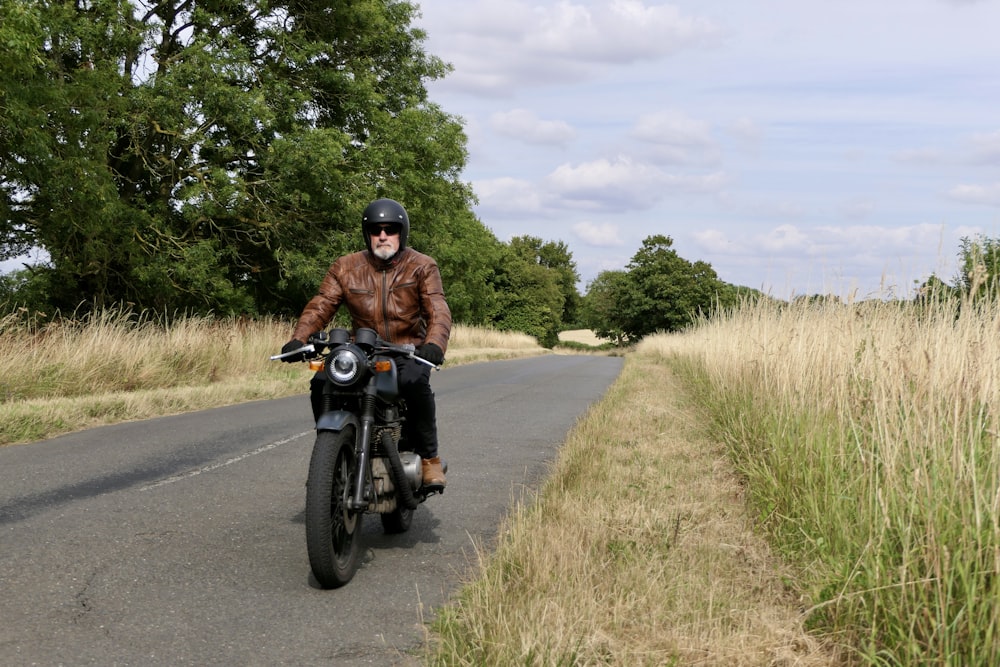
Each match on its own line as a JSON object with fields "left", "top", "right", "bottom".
{"left": 427, "top": 303, "right": 1000, "bottom": 667}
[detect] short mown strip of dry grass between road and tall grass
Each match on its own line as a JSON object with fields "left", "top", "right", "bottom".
{"left": 425, "top": 353, "right": 835, "bottom": 667}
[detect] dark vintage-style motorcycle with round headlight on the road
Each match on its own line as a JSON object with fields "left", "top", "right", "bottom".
{"left": 271, "top": 328, "right": 447, "bottom": 588}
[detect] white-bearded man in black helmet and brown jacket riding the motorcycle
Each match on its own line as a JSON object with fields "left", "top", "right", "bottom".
{"left": 281, "top": 199, "right": 451, "bottom": 490}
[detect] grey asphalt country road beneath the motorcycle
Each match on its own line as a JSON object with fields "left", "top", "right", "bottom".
{"left": 0, "top": 355, "right": 622, "bottom": 666}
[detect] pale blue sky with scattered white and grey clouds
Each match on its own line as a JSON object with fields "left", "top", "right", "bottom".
{"left": 418, "top": 0, "right": 1000, "bottom": 298}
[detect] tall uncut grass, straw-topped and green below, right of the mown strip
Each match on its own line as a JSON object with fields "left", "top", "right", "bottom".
{"left": 640, "top": 302, "right": 1000, "bottom": 665}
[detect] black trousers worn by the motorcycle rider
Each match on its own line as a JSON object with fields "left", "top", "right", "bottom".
{"left": 309, "top": 359, "right": 438, "bottom": 459}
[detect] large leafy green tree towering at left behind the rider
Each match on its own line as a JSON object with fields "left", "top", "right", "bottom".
{"left": 0, "top": 0, "right": 484, "bottom": 312}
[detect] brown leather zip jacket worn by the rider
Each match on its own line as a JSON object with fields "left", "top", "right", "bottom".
{"left": 292, "top": 248, "right": 451, "bottom": 352}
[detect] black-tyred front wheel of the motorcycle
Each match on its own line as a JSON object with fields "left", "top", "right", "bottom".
{"left": 306, "top": 428, "right": 362, "bottom": 588}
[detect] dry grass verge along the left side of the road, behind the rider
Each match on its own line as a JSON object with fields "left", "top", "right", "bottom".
{"left": 0, "top": 309, "right": 545, "bottom": 445}
